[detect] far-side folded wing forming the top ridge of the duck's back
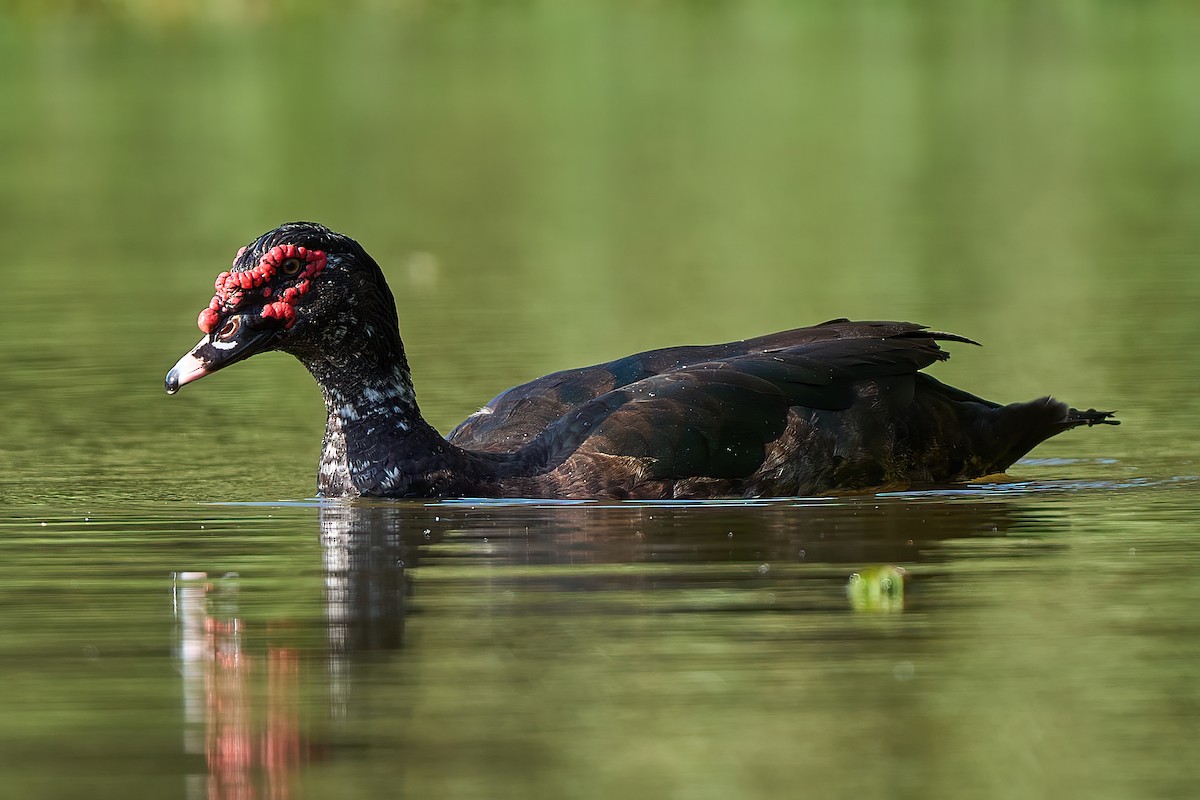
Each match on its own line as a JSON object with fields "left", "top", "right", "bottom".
{"left": 446, "top": 319, "right": 973, "bottom": 452}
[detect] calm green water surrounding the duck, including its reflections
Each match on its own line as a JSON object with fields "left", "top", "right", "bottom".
{"left": 0, "top": 1, "right": 1200, "bottom": 800}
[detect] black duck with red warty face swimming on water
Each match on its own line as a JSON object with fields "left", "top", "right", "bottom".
{"left": 166, "top": 222, "right": 1118, "bottom": 500}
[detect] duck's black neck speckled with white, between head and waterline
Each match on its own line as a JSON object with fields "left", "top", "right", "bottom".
{"left": 295, "top": 335, "right": 461, "bottom": 497}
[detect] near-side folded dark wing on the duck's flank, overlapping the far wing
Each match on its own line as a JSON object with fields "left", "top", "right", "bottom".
{"left": 511, "top": 326, "right": 962, "bottom": 481}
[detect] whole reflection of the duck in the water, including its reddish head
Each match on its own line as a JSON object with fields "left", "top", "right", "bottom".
{"left": 175, "top": 498, "right": 1046, "bottom": 799}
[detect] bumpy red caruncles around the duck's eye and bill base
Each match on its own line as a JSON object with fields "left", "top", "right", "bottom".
{"left": 196, "top": 245, "right": 325, "bottom": 333}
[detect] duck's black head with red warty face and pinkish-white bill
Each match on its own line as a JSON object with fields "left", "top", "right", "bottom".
{"left": 166, "top": 222, "right": 402, "bottom": 395}
